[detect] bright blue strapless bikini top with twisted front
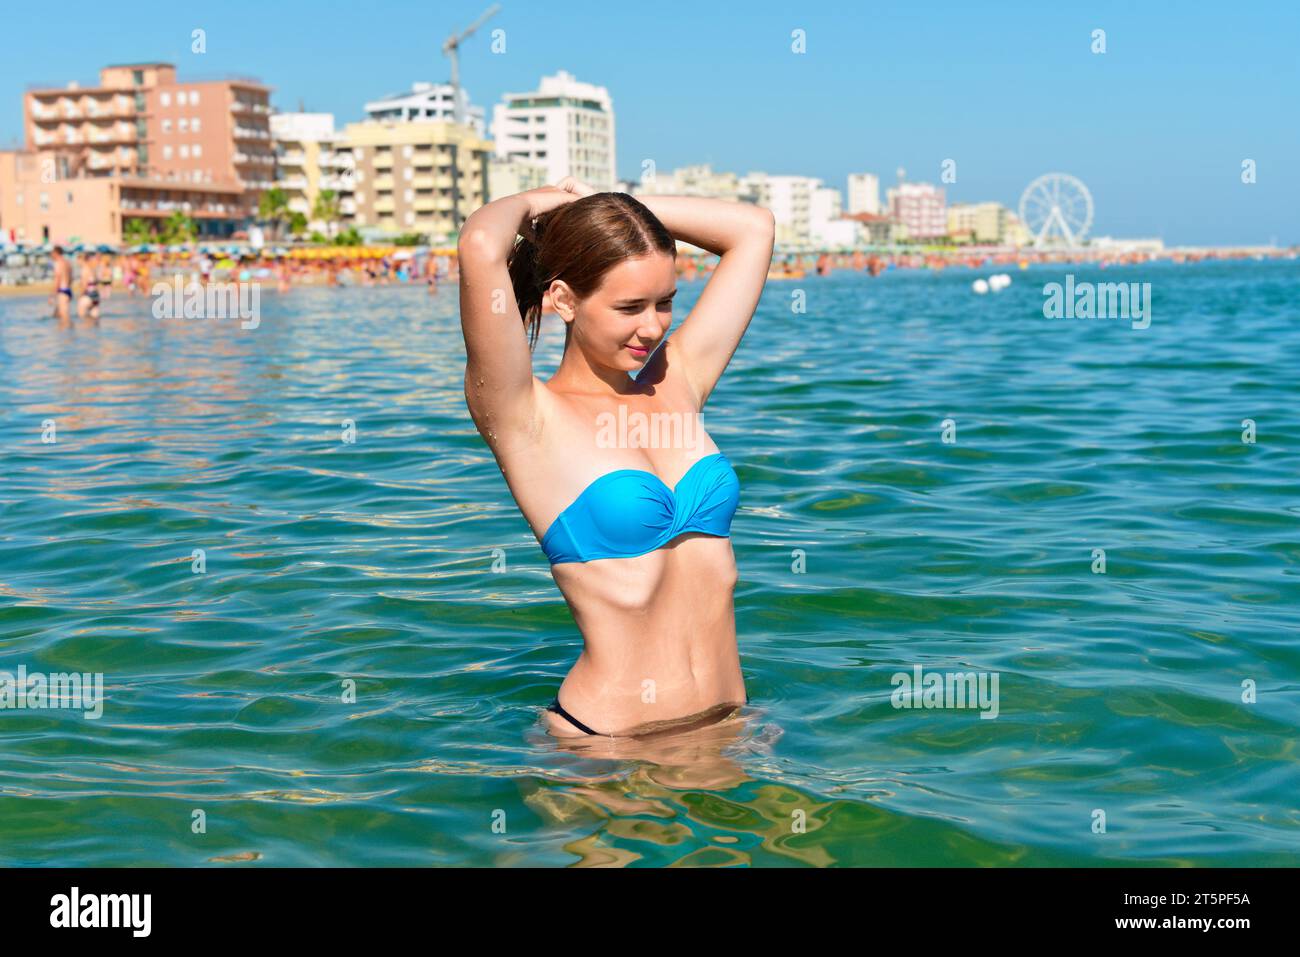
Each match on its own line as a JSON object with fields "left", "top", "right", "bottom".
{"left": 542, "top": 452, "right": 740, "bottom": 564}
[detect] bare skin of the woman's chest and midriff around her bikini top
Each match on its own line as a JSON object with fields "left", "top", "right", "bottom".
{"left": 490, "top": 341, "right": 745, "bottom": 733}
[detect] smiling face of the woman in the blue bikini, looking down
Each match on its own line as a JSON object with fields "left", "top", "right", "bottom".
{"left": 551, "top": 252, "right": 677, "bottom": 371}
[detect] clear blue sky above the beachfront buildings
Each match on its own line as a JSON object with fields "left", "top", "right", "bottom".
{"left": 0, "top": 0, "right": 1300, "bottom": 243}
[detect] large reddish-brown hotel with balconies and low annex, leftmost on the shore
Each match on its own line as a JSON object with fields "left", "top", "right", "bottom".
{"left": 0, "top": 62, "right": 274, "bottom": 243}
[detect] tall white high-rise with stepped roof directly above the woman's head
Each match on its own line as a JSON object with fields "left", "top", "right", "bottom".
{"left": 491, "top": 70, "right": 618, "bottom": 191}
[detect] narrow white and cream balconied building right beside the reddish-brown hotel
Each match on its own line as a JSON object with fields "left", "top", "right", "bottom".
{"left": 270, "top": 113, "right": 352, "bottom": 233}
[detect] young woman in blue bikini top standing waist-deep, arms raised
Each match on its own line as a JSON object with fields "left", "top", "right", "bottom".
{"left": 459, "top": 178, "right": 775, "bottom": 736}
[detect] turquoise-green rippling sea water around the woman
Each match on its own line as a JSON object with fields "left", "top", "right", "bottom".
{"left": 0, "top": 260, "right": 1300, "bottom": 866}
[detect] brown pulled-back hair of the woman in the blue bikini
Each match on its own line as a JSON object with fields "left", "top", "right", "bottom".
{"left": 506, "top": 192, "right": 677, "bottom": 348}
